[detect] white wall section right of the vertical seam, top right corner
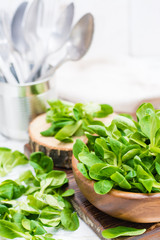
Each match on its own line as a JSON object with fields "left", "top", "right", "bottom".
{"left": 128, "top": 0, "right": 160, "bottom": 56}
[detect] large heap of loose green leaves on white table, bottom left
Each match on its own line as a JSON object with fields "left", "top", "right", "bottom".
{"left": 0, "top": 152, "right": 79, "bottom": 240}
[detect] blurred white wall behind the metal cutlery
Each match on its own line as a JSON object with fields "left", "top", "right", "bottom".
{"left": 0, "top": 0, "right": 160, "bottom": 58}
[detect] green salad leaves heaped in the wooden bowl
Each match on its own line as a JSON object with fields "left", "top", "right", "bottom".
{"left": 73, "top": 103, "right": 160, "bottom": 194}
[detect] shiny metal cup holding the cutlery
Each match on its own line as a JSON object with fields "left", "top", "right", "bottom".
{"left": 0, "top": 77, "right": 57, "bottom": 140}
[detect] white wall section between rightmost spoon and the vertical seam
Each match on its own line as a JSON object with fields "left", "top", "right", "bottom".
{"left": 71, "top": 0, "right": 129, "bottom": 58}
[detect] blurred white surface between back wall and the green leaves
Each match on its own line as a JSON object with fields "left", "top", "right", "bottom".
{"left": 56, "top": 57, "right": 160, "bottom": 113}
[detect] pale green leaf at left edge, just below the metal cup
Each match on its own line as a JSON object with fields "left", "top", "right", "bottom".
{"left": 0, "top": 147, "right": 28, "bottom": 177}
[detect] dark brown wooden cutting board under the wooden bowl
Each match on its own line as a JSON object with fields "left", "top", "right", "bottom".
{"left": 24, "top": 144, "right": 160, "bottom": 240}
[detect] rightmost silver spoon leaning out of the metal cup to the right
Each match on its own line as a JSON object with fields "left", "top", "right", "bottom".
{"left": 42, "top": 13, "right": 94, "bottom": 78}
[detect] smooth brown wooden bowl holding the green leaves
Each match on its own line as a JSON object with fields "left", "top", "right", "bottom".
{"left": 72, "top": 156, "right": 160, "bottom": 223}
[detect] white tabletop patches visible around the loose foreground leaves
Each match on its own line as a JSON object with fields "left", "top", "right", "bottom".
{"left": 0, "top": 135, "right": 99, "bottom": 240}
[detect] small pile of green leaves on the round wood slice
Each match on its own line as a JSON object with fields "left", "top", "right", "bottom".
{"left": 41, "top": 100, "right": 113, "bottom": 142}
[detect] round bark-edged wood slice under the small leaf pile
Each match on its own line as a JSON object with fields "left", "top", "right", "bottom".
{"left": 29, "top": 113, "right": 116, "bottom": 169}
